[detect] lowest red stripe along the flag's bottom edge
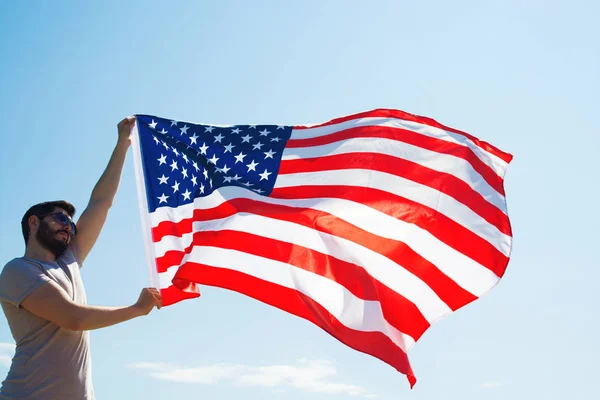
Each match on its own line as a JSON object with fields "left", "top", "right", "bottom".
{"left": 170, "top": 263, "right": 416, "bottom": 388}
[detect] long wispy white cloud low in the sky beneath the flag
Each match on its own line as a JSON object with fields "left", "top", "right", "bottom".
{"left": 128, "top": 358, "right": 376, "bottom": 398}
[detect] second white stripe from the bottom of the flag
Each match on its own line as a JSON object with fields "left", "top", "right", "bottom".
{"left": 155, "top": 213, "right": 451, "bottom": 322}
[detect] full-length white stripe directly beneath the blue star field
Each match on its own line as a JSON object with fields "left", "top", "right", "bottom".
{"left": 150, "top": 187, "right": 498, "bottom": 297}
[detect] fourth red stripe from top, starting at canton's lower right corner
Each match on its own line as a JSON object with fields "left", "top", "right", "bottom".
{"left": 270, "top": 186, "right": 508, "bottom": 277}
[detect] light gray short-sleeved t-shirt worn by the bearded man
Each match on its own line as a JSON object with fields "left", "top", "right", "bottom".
{"left": 0, "top": 247, "right": 94, "bottom": 400}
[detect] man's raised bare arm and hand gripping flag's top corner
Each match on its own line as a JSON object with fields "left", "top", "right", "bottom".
{"left": 73, "top": 117, "right": 135, "bottom": 262}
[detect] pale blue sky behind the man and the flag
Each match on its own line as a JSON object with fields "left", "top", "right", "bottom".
{"left": 0, "top": 0, "right": 600, "bottom": 400}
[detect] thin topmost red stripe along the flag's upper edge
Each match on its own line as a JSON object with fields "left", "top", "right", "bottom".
{"left": 294, "top": 109, "right": 513, "bottom": 164}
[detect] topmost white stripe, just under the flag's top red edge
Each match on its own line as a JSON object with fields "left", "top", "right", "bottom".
{"left": 290, "top": 117, "right": 508, "bottom": 178}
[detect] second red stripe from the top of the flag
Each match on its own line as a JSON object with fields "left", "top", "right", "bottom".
{"left": 285, "top": 126, "right": 505, "bottom": 196}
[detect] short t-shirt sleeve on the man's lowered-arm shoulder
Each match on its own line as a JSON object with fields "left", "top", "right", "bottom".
{"left": 0, "top": 259, "right": 50, "bottom": 307}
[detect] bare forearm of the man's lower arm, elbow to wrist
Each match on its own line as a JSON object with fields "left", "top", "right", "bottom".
{"left": 70, "top": 305, "right": 143, "bottom": 331}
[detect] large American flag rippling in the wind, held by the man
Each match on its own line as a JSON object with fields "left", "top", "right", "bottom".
{"left": 132, "top": 109, "right": 512, "bottom": 387}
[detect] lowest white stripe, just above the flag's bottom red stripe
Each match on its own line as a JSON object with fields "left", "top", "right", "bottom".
{"left": 160, "top": 246, "right": 414, "bottom": 352}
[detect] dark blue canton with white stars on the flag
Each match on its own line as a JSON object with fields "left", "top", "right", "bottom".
{"left": 136, "top": 115, "right": 293, "bottom": 212}
